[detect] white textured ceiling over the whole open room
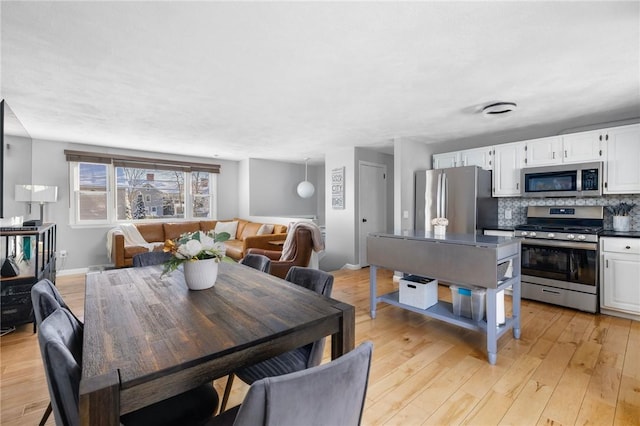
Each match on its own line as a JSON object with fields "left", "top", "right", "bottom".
{"left": 1, "top": 0, "right": 640, "bottom": 163}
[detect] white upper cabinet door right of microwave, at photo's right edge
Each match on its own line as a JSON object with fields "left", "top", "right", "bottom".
{"left": 604, "top": 124, "right": 640, "bottom": 194}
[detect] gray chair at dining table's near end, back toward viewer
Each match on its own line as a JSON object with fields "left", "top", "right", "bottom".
{"left": 208, "top": 342, "right": 373, "bottom": 426}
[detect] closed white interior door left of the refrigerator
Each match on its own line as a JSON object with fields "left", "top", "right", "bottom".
{"left": 358, "top": 161, "right": 387, "bottom": 267}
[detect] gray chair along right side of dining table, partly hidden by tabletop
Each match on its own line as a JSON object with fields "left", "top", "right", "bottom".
{"left": 220, "top": 266, "right": 333, "bottom": 412}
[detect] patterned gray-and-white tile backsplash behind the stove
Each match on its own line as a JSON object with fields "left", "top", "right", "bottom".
{"left": 498, "top": 194, "right": 640, "bottom": 231}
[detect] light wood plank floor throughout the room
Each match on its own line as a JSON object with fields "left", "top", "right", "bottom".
{"left": 0, "top": 269, "right": 640, "bottom": 425}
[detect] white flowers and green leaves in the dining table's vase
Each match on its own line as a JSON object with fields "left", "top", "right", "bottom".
{"left": 163, "top": 231, "right": 230, "bottom": 275}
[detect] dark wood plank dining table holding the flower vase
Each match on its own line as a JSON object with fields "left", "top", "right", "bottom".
{"left": 80, "top": 262, "right": 355, "bottom": 425}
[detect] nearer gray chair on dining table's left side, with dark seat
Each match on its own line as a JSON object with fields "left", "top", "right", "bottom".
{"left": 38, "top": 308, "right": 218, "bottom": 426}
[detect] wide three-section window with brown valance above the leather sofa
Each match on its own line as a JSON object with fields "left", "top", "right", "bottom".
{"left": 65, "top": 151, "right": 219, "bottom": 225}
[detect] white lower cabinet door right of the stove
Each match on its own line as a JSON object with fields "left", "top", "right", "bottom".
{"left": 601, "top": 253, "right": 640, "bottom": 314}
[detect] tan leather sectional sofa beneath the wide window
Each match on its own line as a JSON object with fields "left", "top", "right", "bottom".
{"left": 107, "top": 218, "right": 287, "bottom": 268}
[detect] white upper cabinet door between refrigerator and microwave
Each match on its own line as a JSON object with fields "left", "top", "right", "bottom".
{"left": 493, "top": 142, "right": 524, "bottom": 197}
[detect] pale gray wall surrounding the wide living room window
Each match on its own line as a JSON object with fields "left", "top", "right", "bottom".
{"left": 32, "top": 140, "right": 239, "bottom": 270}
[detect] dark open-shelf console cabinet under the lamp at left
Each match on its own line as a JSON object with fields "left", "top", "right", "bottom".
{"left": 0, "top": 223, "right": 56, "bottom": 329}
